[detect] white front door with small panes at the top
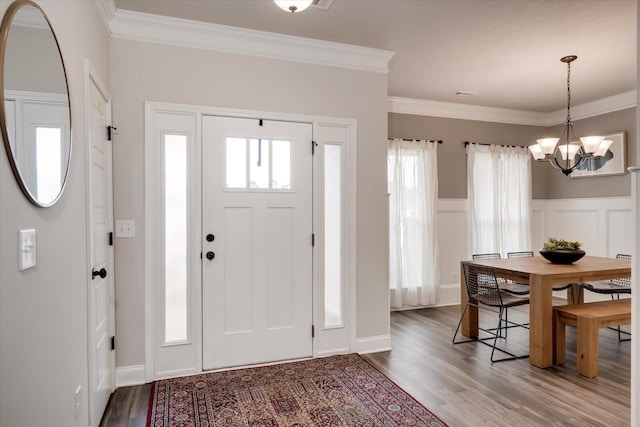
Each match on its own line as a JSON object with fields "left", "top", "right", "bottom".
{"left": 202, "top": 116, "right": 313, "bottom": 369}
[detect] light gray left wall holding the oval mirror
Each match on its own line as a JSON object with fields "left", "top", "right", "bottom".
{"left": 0, "top": 0, "right": 109, "bottom": 427}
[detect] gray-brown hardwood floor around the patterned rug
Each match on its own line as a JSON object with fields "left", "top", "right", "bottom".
{"left": 100, "top": 306, "right": 631, "bottom": 427}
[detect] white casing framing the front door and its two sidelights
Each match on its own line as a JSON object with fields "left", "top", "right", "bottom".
{"left": 144, "top": 101, "right": 357, "bottom": 382}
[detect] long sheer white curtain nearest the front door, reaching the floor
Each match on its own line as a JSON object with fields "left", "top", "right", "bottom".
{"left": 387, "top": 139, "right": 440, "bottom": 308}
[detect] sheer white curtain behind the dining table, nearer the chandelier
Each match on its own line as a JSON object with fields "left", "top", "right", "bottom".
{"left": 467, "top": 144, "right": 532, "bottom": 257}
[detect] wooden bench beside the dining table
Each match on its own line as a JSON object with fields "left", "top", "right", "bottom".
{"left": 553, "top": 299, "right": 631, "bottom": 378}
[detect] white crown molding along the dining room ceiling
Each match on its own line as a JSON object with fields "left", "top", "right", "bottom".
{"left": 388, "top": 90, "right": 637, "bottom": 127}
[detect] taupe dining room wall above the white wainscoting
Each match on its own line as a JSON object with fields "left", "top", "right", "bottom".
{"left": 389, "top": 108, "right": 636, "bottom": 199}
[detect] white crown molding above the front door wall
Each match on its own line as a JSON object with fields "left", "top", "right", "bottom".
{"left": 109, "top": 9, "right": 395, "bottom": 74}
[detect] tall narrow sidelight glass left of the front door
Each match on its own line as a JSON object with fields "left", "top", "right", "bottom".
{"left": 164, "top": 135, "right": 187, "bottom": 343}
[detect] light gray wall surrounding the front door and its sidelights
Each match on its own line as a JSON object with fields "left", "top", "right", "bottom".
{"left": 111, "top": 39, "right": 389, "bottom": 367}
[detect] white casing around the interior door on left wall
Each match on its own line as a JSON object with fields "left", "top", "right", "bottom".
{"left": 84, "top": 59, "right": 116, "bottom": 426}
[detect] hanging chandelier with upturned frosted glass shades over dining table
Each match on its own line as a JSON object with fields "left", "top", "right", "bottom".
{"left": 529, "top": 55, "right": 612, "bottom": 176}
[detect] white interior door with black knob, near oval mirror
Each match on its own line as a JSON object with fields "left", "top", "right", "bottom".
{"left": 87, "top": 68, "right": 115, "bottom": 426}
